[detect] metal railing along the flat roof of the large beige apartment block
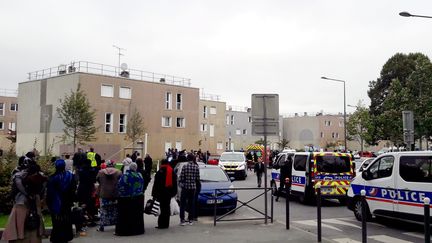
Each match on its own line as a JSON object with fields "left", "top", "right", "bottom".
{"left": 28, "top": 61, "right": 191, "bottom": 87}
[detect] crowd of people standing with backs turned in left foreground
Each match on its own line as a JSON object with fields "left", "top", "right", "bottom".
{"left": 2, "top": 148, "right": 209, "bottom": 243}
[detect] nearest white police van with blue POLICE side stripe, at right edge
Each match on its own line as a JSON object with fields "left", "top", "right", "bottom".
{"left": 348, "top": 151, "right": 432, "bottom": 222}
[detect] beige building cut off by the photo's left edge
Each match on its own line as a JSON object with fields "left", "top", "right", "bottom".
{"left": 0, "top": 89, "right": 18, "bottom": 153}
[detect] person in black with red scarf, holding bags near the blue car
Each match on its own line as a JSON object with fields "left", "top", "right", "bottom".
{"left": 152, "top": 159, "right": 177, "bottom": 229}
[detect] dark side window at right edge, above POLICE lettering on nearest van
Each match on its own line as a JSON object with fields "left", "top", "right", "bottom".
{"left": 399, "top": 156, "right": 432, "bottom": 183}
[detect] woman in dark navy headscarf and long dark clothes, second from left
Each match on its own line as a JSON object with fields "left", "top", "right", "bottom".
{"left": 47, "top": 159, "right": 76, "bottom": 243}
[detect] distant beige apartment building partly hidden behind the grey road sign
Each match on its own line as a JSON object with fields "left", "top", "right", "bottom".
{"left": 225, "top": 106, "right": 282, "bottom": 150}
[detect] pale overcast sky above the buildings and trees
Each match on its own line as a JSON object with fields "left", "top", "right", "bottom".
{"left": 0, "top": 0, "right": 432, "bottom": 113}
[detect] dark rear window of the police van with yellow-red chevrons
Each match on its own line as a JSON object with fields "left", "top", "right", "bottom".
{"left": 316, "top": 155, "right": 351, "bottom": 173}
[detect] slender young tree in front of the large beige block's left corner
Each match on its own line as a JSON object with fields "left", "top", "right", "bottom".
{"left": 57, "top": 84, "right": 97, "bottom": 151}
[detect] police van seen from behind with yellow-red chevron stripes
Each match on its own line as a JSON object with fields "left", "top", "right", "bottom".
{"left": 270, "top": 152, "right": 355, "bottom": 204}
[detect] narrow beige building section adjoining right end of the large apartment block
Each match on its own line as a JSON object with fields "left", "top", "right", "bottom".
{"left": 198, "top": 94, "right": 226, "bottom": 155}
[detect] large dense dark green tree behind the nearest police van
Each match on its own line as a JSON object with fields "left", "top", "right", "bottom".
{"left": 368, "top": 53, "right": 432, "bottom": 145}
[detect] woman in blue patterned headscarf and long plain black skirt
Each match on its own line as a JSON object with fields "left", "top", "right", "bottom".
{"left": 115, "top": 163, "right": 144, "bottom": 236}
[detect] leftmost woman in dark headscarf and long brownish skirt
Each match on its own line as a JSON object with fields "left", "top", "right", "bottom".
{"left": 1, "top": 152, "right": 46, "bottom": 243}
